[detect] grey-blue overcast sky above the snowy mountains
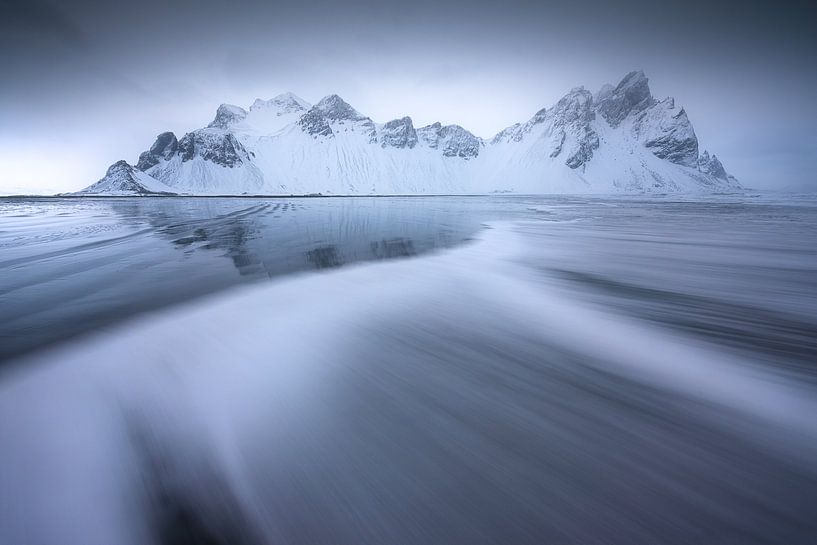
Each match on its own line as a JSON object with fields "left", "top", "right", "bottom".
{"left": 0, "top": 0, "right": 817, "bottom": 192}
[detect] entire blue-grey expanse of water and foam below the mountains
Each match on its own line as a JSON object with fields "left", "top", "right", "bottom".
{"left": 0, "top": 195, "right": 817, "bottom": 544}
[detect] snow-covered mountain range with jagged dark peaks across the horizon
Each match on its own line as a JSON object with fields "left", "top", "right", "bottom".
{"left": 82, "top": 71, "right": 739, "bottom": 195}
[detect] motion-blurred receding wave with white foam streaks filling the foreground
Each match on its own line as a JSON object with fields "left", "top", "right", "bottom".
{"left": 0, "top": 212, "right": 817, "bottom": 544}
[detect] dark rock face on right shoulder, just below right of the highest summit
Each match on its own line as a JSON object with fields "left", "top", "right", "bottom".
{"left": 634, "top": 98, "right": 698, "bottom": 168}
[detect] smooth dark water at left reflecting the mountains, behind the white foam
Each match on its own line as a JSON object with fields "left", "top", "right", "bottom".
{"left": 0, "top": 198, "right": 525, "bottom": 361}
